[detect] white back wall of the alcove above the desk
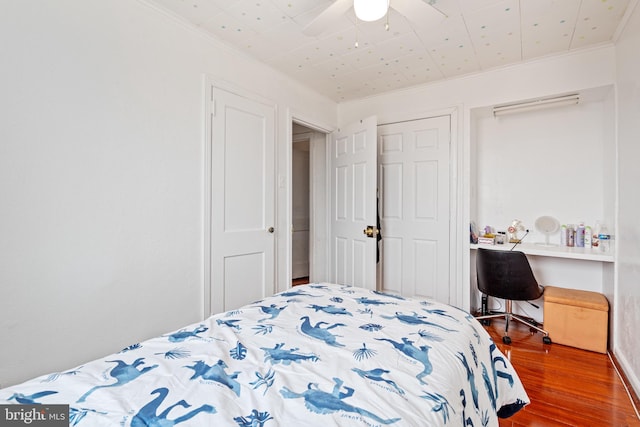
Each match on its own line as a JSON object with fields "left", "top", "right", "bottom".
{"left": 472, "top": 101, "right": 615, "bottom": 244}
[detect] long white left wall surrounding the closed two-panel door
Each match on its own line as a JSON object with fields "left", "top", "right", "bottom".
{"left": 0, "top": 0, "right": 336, "bottom": 386}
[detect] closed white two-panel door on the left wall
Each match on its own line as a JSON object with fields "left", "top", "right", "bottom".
{"left": 210, "top": 87, "right": 275, "bottom": 313}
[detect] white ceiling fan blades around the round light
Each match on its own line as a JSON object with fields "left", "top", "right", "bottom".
{"left": 303, "top": 0, "right": 447, "bottom": 36}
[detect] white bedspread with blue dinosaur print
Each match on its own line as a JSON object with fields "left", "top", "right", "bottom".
{"left": 0, "top": 284, "right": 529, "bottom": 427}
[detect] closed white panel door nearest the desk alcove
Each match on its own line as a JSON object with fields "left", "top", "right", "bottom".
{"left": 378, "top": 115, "right": 451, "bottom": 303}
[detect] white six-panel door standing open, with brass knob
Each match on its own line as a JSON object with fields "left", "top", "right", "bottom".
{"left": 330, "top": 117, "right": 377, "bottom": 289}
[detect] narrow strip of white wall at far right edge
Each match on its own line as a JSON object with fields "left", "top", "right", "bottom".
{"left": 614, "top": 0, "right": 640, "bottom": 394}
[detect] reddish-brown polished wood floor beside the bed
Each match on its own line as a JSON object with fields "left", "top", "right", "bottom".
{"left": 485, "top": 319, "right": 640, "bottom": 427}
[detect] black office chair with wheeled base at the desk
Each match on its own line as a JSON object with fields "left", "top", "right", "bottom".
{"left": 476, "top": 248, "right": 551, "bottom": 344}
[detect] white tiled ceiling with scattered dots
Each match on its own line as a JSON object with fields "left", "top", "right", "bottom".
{"left": 149, "top": 0, "right": 634, "bottom": 102}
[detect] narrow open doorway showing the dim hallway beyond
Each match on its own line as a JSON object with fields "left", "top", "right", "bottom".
{"left": 290, "top": 122, "right": 329, "bottom": 286}
